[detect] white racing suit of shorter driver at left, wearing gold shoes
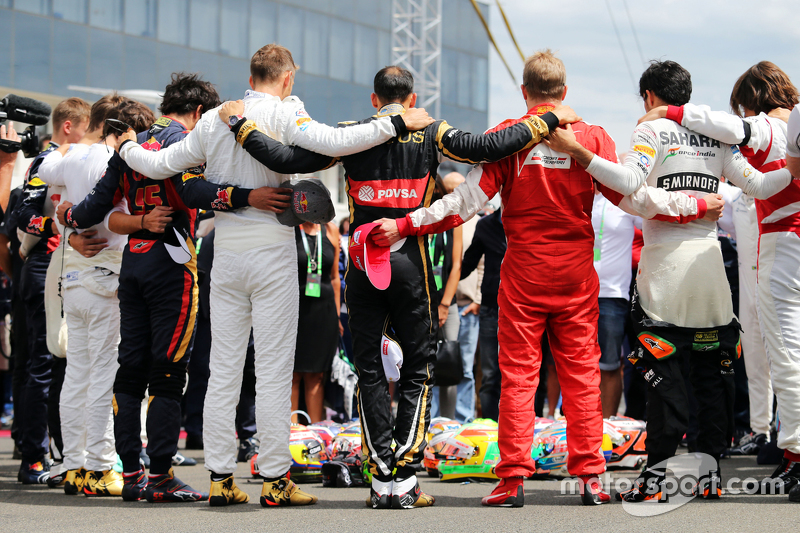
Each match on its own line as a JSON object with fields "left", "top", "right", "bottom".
{"left": 39, "top": 144, "right": 127, "bottom": 471}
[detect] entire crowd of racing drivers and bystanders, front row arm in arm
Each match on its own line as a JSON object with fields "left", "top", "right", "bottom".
{"left": 0, "top": 40, "right": 800, "bottom": 508}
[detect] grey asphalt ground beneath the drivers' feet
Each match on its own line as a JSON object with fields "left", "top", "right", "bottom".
{"left": 0, "top": 438, "right": 800, "bottom": 533}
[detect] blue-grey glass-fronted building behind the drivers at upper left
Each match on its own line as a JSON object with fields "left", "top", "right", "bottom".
{"left": 0, "top": 0, "right": 489, "bottom": 212}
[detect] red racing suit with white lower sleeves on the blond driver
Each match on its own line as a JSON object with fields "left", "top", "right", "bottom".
{"left": 397, "top": 105, "right": 706, "bottom": 478}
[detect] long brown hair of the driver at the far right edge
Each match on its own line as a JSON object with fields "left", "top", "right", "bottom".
{"left": 731, "top": 61, "right": 798, "bottom": 116}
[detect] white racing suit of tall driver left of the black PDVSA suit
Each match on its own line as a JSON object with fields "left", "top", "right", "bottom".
{"left": 120, "top": 91, "right": 402, "bottom": 478}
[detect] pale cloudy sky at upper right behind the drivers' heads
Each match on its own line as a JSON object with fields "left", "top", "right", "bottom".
{"left": 489, "top": 0, "right": 800, "bottom": 151}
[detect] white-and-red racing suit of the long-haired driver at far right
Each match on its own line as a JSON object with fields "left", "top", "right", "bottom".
{"left": 670, "top": 104, "right": 800, "bottom": 454}
